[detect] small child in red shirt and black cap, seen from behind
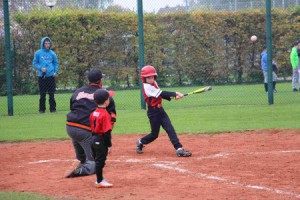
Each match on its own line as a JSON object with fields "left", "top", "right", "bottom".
{"left": 90, "top": 89, "right": 113, "bottom": 188}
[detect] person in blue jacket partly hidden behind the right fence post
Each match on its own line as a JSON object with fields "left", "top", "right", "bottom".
{"left": 261, "top": 47, "right": 277, "bottom": 93}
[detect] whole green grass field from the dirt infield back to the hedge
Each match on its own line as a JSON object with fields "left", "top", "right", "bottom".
{"left": 0, "top": 84, "right": 300, "bottom": 141}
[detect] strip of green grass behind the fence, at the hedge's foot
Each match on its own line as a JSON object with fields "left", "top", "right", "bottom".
{"left": 0, "top": 83, "right": 300, "bottom": 115}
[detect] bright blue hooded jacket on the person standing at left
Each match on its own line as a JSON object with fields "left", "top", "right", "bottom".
{"left": 33, "top": 37, "right": 59, "bottom": 77}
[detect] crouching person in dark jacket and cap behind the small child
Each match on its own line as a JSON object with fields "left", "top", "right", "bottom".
{"left": 64, "top": 70, "right": 116, "bottom": 178}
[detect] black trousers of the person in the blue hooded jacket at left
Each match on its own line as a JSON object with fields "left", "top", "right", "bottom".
{"left": 38, "top": 76, "right": 56, "bottom": 112}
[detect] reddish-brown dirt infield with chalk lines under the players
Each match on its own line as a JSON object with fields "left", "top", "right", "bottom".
{"left": 0, "top": 130, "right": 300, "bottom": 200}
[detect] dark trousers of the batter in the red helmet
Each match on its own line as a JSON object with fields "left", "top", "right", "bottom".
{"left": 141, "top": 108, "right": 182, "bottom": 149}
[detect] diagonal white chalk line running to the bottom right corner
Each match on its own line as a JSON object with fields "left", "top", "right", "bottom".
{"left": 153, "top": 164, "right": 300, "bottom": 198}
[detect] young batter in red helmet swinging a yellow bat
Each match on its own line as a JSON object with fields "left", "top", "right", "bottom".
{"left": 136, "top": 65, "right": 192, "bottom": 157}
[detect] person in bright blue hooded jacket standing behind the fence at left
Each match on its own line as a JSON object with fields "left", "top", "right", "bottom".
{"left": 33, "top": 37, "right": 59, "bottom": 113}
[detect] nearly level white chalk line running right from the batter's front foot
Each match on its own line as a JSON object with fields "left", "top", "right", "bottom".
{"left": 197, "top": 150, "right": 300, "bottom": 160}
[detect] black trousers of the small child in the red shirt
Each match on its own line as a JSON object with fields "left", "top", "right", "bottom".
{"left": 92, "top": 134, "right": 108, "bottom": 183}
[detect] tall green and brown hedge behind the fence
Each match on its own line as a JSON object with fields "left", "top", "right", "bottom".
{"left": 0, "top": 8, "right": 300, "bottom": 94}
